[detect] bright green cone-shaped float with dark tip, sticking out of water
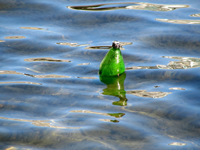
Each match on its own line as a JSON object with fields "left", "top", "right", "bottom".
{"left": 99, "top": 41, "right": 125, "bottom": 76}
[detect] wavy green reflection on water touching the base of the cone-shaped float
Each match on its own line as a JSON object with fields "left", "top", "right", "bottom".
{"left": 100, "top": 73, "right": 127, "bottom": 106}
